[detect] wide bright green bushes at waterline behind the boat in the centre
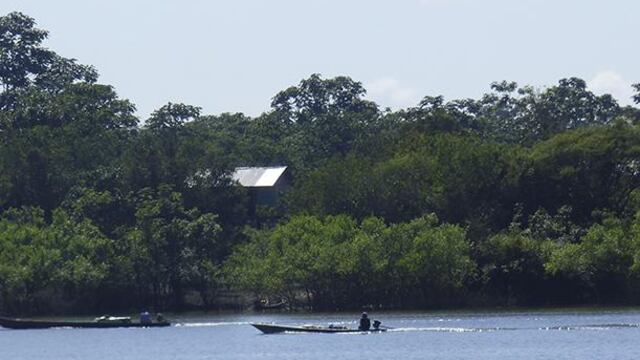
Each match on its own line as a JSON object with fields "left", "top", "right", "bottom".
{"left": 225, "top": 215, "right": 474, "bottom": 309}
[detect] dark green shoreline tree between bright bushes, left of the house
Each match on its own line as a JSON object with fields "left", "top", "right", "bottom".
{"left": 125, "top": 185, "right": 225, "bottom": 308}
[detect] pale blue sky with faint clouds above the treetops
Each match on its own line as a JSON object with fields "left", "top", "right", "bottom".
{"left": 0, "top": 0, "right": 640, "bottom": 119}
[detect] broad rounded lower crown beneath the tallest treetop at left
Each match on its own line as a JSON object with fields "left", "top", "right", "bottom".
{"left": 0, "top": 83, "right": 137, "bottom": 213}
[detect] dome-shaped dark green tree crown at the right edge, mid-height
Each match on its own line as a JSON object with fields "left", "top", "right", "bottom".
{"left": 525, "top": 123, "right": 640, "bottom": 222}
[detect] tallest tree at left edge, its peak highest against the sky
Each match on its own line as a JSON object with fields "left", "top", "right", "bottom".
{"left": 0, "top": 12, "right": 137, "bottom": 216}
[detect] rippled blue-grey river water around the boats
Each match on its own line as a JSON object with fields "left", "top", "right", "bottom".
{"left": 0, "top": 310, "right": 640, "bottom": 360}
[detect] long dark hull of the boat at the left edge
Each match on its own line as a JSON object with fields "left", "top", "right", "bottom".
{"left": 0, "top": 317, "right": 171, "bottom": 329}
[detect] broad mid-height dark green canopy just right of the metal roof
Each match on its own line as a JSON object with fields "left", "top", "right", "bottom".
{"left": 291, "top": 134, "right": 526, "bottom": 233}
